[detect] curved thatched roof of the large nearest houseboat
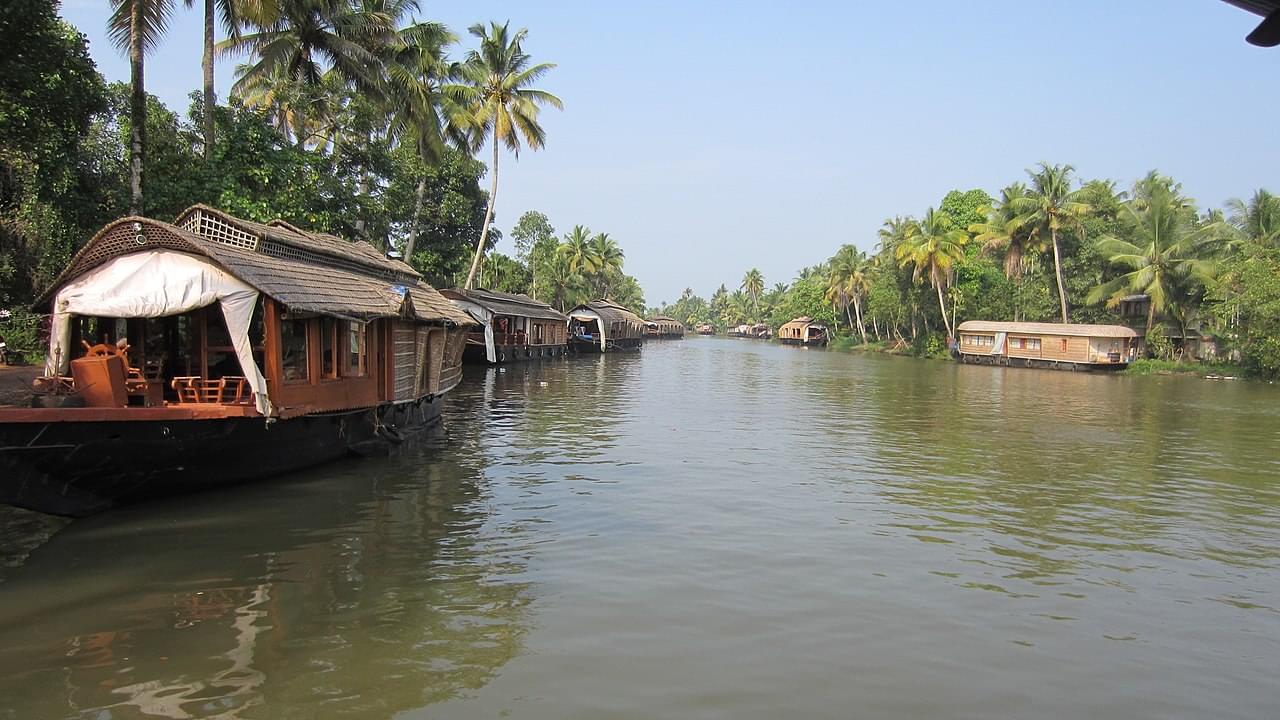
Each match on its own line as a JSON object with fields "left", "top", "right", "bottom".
{"left": 37, "top": 210, "right": 475, "bottom": 325}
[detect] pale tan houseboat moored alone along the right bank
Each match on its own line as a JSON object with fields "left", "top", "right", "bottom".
{"left": 954, "top": 320, "right": 1140, "bottom": 370}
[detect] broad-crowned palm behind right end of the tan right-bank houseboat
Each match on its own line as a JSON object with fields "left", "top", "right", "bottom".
{"left": 1088, "top": 182, "right": 1224, "bottom": 333}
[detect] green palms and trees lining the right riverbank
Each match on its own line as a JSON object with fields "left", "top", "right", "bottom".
{"left": 657, "top": 163, "right": 1280, "bottom": 377}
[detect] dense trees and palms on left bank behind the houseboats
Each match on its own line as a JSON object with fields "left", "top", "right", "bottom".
{"left": 0, "top": 0, "right": 586, "bottom": 326}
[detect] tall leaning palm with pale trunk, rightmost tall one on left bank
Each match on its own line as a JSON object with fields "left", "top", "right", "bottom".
{"left": 453, "top": 22, "right": 563, "bottom": 288}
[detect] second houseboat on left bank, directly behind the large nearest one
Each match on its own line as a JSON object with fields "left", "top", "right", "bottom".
{"left": 440, "top": 290, "right": 568, "bottom": 365}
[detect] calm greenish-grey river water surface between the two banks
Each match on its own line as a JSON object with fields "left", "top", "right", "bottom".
{"left": 0, "top": 338, "right": 1280, "bottom": 720}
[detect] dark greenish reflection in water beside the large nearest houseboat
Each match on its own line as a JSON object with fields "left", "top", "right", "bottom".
{"left": 0, "top": 427, "right": 531, "bottom": 719}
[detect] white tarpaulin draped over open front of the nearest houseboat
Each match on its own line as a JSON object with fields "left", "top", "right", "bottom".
{"left": 45, "top": 250, "right": 271, "bottom": 415}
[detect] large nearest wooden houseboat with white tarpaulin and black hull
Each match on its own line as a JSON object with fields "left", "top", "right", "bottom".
{"left": 0, "top": 206, "right": 475, "bottom": 516}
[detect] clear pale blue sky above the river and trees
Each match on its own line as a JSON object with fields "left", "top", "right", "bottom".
{"left": 61, "top": 0, "right": 1280, "bottom": 305}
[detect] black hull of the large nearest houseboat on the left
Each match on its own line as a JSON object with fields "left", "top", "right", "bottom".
{"left": 0, "top": 397, "right": 440, "bottom": 518}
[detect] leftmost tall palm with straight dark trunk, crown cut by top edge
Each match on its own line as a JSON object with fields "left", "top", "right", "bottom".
{"left": 108, "top": 0, "right": 180, "bottom": 215}
